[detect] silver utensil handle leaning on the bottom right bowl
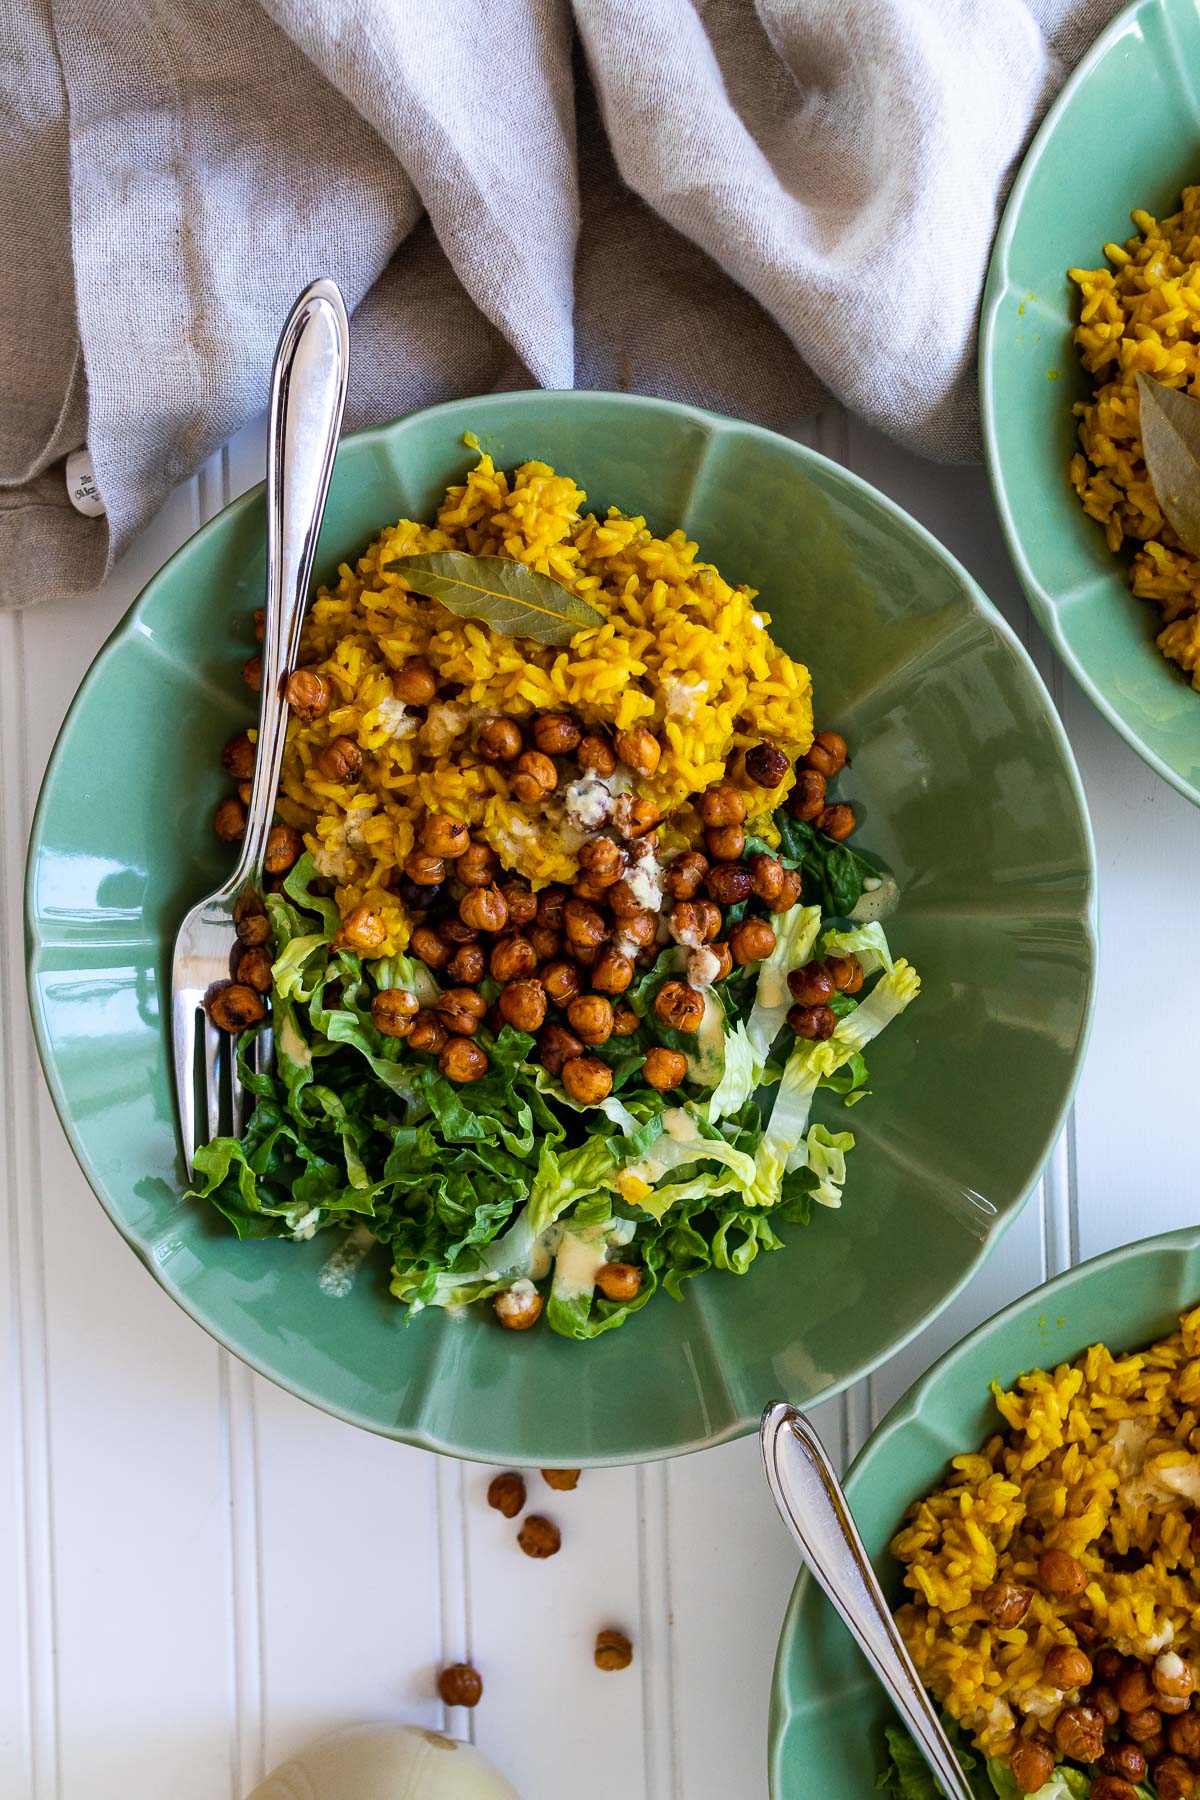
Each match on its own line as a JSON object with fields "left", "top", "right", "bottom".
{"left": 761, "top": 1402, "right": 973, "bottom": 1800}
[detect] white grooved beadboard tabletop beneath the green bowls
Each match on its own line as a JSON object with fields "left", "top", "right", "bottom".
{"left": 0, "top": 416, "right": 1200, "bottom": 1800}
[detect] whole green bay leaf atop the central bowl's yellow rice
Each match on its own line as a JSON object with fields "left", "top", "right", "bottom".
{"left": 385, "top": 551, "right": 604, "bottom": 646}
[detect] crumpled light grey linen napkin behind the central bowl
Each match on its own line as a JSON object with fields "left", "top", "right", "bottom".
{"left": 0, "top": 0, "right": 1115, "bottom": 607}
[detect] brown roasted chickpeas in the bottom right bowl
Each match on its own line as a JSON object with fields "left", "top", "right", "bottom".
{"left": 981, "top": 1550, "right": 1200, "bottom": 1800}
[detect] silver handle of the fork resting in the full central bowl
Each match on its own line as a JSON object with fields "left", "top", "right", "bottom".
{"left": 234, "top": 279, "right": 349, "bottom": 887}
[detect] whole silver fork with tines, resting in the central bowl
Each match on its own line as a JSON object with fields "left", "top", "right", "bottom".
{"left": 171, "top": 281, "right": 349, "bottom": 1170}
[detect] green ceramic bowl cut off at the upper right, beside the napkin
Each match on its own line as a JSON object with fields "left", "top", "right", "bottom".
{"left": 981, "top": 0, "right": 1200, "bottom": 805}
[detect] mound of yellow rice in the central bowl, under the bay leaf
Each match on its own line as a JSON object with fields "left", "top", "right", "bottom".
{"left": 279, "top": 455, "right": 813, "bottom": 956}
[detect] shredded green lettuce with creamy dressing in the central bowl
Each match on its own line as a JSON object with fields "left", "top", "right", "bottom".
{"left": 194, "top": 814, "right": 919, "bottom": 1339}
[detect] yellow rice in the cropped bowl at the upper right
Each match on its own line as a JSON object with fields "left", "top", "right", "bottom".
{"left": 1069, "top": 187, "right": 1200, "bottom": 689}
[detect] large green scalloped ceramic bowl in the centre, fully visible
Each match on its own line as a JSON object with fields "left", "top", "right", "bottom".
{"left": 29, "top": 392, "right": 1094, "bottom": 1465}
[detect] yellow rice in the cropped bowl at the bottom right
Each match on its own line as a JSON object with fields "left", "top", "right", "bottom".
{"left": 892, "top": 1307, "right": 1200, "bottom": 1757}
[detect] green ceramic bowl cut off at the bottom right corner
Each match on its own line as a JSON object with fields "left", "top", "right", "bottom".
{"left": 770, "top": 1228, "right": 1200, "bottom": 1800}
